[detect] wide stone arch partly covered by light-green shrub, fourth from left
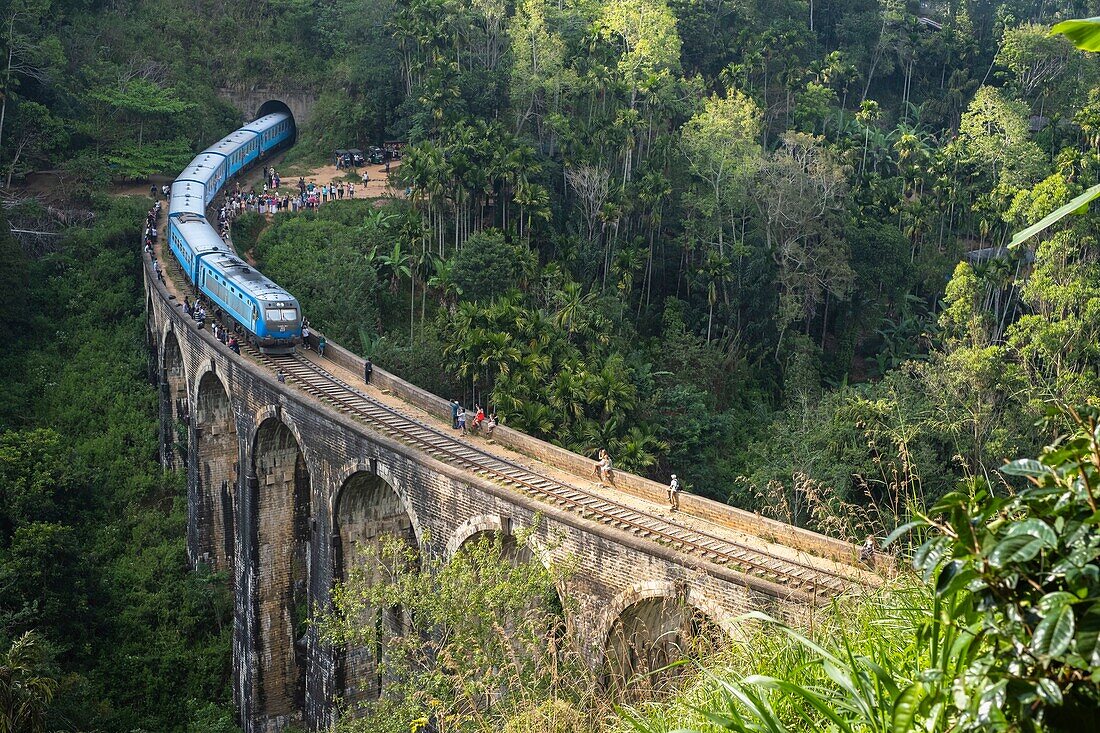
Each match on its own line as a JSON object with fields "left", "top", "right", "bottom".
{"left": 332, "top": 469, "right": 420, "bottom": 705}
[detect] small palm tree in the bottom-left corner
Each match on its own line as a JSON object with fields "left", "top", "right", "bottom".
{"left": 0, "top": 632, "right": 57, "bottom": 733}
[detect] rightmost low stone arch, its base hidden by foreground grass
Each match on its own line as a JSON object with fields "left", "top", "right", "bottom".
{"left": 597, "top": 581, "right": 727, "bottom": 697}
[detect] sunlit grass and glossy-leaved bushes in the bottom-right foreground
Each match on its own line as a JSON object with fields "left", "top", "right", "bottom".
{"left": 628, "top": 409, "right": 1100, "bottom": 733}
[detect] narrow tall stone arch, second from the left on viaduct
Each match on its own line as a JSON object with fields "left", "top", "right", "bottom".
{"left": 193, "top": 365, "right": 240, "bottom": 577}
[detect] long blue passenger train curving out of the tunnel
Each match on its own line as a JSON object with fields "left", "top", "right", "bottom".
{"left": 167, "top": 112, "right": 301, "bottom": 354}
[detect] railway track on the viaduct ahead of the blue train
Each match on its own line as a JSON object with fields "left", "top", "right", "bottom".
{"left": 242, "top": 344, "right": 861, "bottom": 598}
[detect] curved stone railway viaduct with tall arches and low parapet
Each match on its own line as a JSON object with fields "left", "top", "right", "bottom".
{"left": 145, "top": 96, "right": 871, "bottom": 733}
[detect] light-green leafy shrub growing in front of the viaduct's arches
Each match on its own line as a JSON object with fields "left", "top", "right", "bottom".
{"left": 320, "top": 532, "right": 590, "bottom": 733}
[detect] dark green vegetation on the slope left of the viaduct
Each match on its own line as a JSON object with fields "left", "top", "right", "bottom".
{"left": 0, "top": 201, "right": 232, "bottom": 732}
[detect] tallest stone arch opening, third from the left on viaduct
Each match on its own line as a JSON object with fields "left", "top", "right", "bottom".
{"left": 249, "top": 409, "right": 312, "bottom": 716}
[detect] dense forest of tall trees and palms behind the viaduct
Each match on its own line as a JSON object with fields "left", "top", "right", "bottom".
{"left": 12, "top": 0, "right": 1100, "bottom": 519}
